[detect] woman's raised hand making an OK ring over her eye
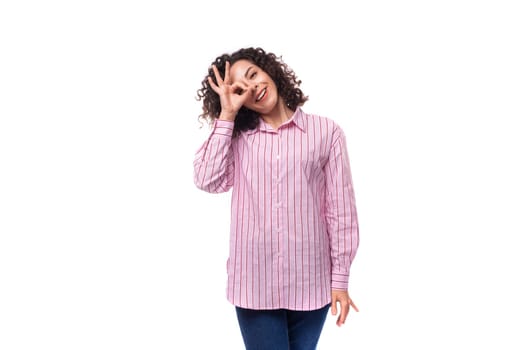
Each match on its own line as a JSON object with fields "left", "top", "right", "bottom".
{"left": 208, "top": 62, "right": 251, "bottom": 121}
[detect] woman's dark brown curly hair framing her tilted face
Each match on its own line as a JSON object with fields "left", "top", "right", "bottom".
{"left": 196, "top": 47, "right": 308, "bottom": 137}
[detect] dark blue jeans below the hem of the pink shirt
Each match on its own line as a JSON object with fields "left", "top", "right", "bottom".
{"left": 236, "top": 304, "right": 330, "bottom": 350}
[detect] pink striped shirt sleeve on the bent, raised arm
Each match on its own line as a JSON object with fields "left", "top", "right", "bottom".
{"left": 193, "top": 120, "right": 234, "bottom": 193}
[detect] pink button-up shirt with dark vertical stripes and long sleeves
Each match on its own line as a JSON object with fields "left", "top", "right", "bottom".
{"left": 194, "top": 108, "right": 359, "bottom": 310}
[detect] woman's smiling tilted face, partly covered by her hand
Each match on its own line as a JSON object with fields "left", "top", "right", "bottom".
{"left": 230, "top": 59, "right": 279, "bottom": 115}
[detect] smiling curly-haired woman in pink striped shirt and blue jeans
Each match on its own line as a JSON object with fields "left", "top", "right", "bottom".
{"left": 194, "top": 48, "right": 359, "bottom": 350}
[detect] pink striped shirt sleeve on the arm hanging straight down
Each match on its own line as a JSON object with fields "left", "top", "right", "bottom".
{"left": 325, "top": 126, "right": 359, "bottom": 290}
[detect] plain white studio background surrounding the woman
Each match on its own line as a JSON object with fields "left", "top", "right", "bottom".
{"left": 0, "top": 0, "right": 525, "bottom": 350}
